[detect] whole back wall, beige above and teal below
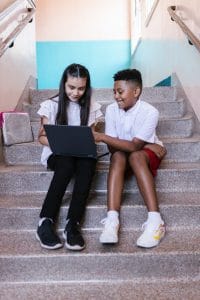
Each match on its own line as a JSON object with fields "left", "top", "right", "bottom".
{"left": 36, "top": 0, "right": 131, "bottom": 89}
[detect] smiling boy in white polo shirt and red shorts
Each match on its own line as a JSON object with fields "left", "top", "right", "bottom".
{"left": 94, "top": 69, "right": 166, "bottom": 248}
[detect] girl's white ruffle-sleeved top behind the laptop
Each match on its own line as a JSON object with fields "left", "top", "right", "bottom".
{"left": 37, "top": 97, "right": 102, "bottom": 166}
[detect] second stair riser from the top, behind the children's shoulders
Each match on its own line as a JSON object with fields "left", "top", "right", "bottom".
{"left": 23, "top": 99, "right": 186, "bottom": 120}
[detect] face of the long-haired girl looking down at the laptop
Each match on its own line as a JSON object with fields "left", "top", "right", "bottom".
{"left": 65, "top": 76, "right": 87, "bottom": 102}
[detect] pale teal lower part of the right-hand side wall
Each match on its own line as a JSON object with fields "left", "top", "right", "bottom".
{"left": 131, "top": 39, "right": 200, "bottom": 86}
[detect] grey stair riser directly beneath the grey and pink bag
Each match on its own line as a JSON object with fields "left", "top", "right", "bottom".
{"left": 4, "top": 135, "right": 200, "bottom": 165}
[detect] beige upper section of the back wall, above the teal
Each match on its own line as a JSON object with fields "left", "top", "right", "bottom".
{"left": 36, "top": 0, "right": 130, "bottom": 41}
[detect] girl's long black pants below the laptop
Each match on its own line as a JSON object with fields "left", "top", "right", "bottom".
{"left": 40, "top": 155, "right": 96, "bottom": 222}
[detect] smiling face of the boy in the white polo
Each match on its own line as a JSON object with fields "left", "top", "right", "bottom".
{"left": 113, "top": 80, "right": 141, "bottom": 111}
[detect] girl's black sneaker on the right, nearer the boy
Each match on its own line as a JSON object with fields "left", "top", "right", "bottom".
{"left": 63, "top": 220, "right": 85, "bottom": 250}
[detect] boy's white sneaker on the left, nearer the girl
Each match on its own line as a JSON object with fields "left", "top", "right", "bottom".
{"left": 99, "top": 218, "right": 119, "bottom": 244}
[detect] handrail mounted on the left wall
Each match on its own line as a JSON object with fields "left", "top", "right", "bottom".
{"left": 0, "top": 1, "right": 35, "bottom": 57}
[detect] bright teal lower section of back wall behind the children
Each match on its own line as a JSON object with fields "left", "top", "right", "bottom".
{"left": 36, "top": 40, "right": 131, "bottom": 89}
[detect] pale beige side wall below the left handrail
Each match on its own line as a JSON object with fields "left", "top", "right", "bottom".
{"left": 0, "top": 8, "right": 36, "bottom": 111}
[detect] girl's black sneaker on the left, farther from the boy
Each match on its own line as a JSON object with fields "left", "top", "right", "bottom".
{"left": 36, "top": 219, "right": 63, "bottom": 249}
